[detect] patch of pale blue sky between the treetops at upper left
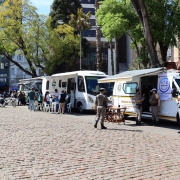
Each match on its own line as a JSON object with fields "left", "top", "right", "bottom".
{"left": 30, "top": 0, "right": 53, "bottom": 15}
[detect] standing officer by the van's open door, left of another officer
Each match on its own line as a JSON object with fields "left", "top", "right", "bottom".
{"left": 134, "top": 89, "right": 143, "bottom": 125}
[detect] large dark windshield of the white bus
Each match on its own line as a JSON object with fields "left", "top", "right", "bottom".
{"left": 85, "top": 76, "right": 114, "bottom": 96}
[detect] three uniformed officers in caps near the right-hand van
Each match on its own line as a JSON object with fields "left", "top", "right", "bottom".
{"left": 94, "top": 88, "right": 160, "bottom": 129}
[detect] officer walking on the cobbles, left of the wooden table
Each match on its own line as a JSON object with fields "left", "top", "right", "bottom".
{"left": 94, "top": 88, "right": 109, "bottom": 129}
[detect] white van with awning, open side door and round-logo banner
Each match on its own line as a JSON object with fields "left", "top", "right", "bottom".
{"left": 98, "top": 68, "right": 180, "bottom": 124}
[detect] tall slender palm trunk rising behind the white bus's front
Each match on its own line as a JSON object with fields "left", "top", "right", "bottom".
{"left": 95, "top": 0, "right": 102, "bottom": 71}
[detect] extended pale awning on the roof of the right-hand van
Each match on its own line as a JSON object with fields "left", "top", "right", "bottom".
{"left": 98, "top": 68, "right": 165, "bottom": 83}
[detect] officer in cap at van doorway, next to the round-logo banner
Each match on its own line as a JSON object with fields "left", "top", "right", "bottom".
{"left": 149, "top": 88, "right": 160, "bottom": 126}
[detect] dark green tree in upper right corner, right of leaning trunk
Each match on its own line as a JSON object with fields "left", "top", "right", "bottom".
{"left": 146, "top": 0, "right": 180, "bottom": 62}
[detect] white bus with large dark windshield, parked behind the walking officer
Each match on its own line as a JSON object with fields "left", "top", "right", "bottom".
{"left": 42, "top": 71, "right": 114, "bottom": 113}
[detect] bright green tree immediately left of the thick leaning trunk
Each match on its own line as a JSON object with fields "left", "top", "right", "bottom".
{"left": 96, "top": 0, "right": 148, "bottom": 73}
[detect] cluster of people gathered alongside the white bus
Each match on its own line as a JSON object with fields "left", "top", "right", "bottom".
{"left": 28, "top": 88, "right": 69, "bottom": 114}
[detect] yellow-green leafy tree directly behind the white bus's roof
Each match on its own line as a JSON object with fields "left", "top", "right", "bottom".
{"left": 45, "top": 24, "right": 80, "bottom": 74}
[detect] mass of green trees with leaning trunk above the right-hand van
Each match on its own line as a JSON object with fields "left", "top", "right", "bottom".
{"left": 97, "top": 0, "right": 180, "bottom": 67}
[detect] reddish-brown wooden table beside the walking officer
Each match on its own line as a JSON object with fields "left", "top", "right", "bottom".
{"left": 104, "top": 106, "right": 127, "bottom": 124}
